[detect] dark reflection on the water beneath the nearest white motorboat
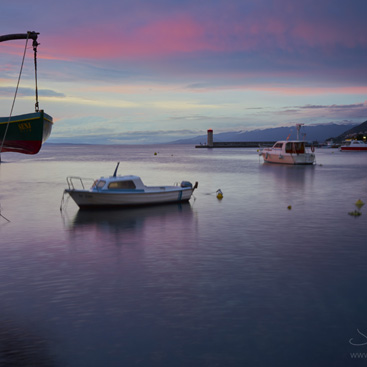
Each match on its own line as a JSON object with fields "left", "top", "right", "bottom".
{"left": 66, "top": 203, "right": 194, "bottom": 244}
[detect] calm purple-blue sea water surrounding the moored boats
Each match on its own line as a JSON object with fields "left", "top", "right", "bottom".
{"left": 0, "top": 144, "right": 367, "bottom": 367}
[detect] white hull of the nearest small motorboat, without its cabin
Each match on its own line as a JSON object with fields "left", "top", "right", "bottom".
{"left": 65, "top": 187, "right": 193, "bottom": 209}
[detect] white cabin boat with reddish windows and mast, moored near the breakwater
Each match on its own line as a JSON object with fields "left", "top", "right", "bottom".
{"left": 259, "top": 124, "right": 315, "bottom": 165}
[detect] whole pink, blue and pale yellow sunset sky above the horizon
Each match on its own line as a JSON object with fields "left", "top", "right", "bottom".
{"left": 0, "top": 0, "right": 367, "bottom": 144}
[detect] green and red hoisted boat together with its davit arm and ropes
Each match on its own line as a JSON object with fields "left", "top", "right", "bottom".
{"left": 0, "top": 32, "right": 53, "bottom": 154}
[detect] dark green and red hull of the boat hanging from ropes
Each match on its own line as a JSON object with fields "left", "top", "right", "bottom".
{"left": 0, "top": 110, "right": 53, "bottom": 154}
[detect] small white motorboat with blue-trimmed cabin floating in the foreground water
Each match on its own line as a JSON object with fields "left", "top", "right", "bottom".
{"left": 60, "top": 163, "right": 198, "bottom": 209}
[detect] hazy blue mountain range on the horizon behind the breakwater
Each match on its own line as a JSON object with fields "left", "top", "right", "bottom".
{"left": 173, "top": 121, "right": 367, "bottom": 144}
